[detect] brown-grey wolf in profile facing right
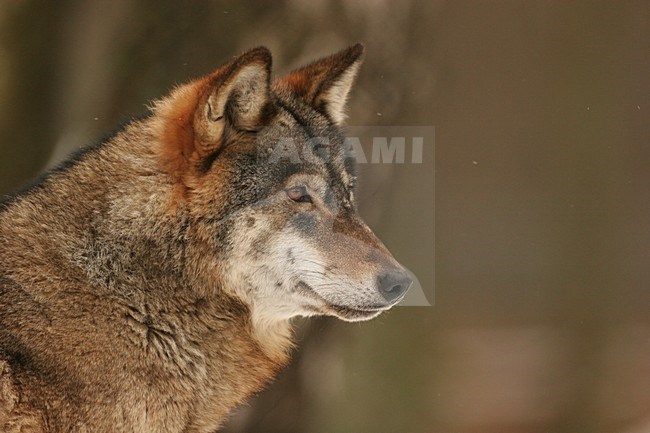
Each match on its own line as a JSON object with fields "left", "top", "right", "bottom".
{"left": 0, "top": 44, "right": 411, "bottom": 433}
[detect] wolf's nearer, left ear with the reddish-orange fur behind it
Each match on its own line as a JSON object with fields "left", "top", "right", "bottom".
{"left": 154, "top": 47, "right": 271, "bottom": 184}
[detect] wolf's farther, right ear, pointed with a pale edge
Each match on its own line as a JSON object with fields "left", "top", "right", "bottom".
{"left": 275, "top": 44, "right": 363, "bottom": 124}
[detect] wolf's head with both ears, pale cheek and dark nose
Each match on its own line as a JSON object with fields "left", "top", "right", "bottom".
{"left": 154, "top": 44, "right": 411, "bottom": 328}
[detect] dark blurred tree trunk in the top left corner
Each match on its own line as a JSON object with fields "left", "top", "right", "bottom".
{"left": 0, "top": 1, "right": 69, "bottom": 194}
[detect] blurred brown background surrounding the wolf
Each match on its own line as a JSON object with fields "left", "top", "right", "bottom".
{"left": 0, "top": 0, "right": 650, "bottom": 433}
